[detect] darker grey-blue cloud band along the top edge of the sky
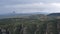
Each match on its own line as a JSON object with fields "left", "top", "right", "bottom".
{"left": 0, "top": 0, "right": 60, "bottom": 5}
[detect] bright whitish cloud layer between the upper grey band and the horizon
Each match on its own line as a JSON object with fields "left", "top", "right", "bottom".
{"left": 5, "top": 2, "right": 60, "bottom": 12}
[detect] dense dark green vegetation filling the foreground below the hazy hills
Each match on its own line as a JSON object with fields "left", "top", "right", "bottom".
{"left": 0, "top": 15, "right": 60, "bottom": 34}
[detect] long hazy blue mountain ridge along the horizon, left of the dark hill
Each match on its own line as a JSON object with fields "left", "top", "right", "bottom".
{"left": 0, "top": 12, "right": 48, "bottom": 19}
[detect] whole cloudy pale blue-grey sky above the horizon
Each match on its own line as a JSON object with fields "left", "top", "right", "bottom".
{"left": 0, "top": 0, "right": 60, "bottom": 14}
